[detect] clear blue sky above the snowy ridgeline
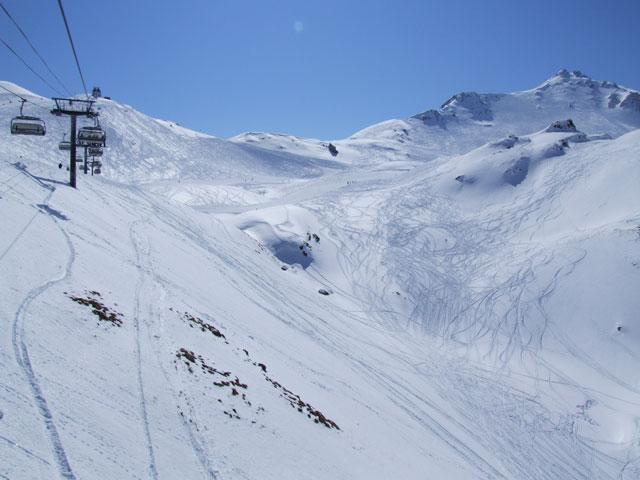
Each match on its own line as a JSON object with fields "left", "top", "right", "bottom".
{"left": 0, "top": 0, "right": 640, "bottom": 139}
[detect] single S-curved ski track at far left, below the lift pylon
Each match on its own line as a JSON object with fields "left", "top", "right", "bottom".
{"left": 11, "top": 191, "right": 75, "bottom": 479}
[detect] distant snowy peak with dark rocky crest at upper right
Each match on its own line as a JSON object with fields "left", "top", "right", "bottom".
{"left": 351, "top": 70, "right": 640, "bottom": 159}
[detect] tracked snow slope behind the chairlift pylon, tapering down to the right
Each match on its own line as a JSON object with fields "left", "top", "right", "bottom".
{"left": 0, "top": 82, "right": 348, "bottom": 187}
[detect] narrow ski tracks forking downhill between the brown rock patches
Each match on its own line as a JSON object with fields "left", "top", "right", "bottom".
{"left": 129, "top": 220, "right": 218, "bottom": 480}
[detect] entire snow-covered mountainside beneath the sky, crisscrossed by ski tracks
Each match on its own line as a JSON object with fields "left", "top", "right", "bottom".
{"left": 0, "top": 71, "right": 640, "bottom": 480}
